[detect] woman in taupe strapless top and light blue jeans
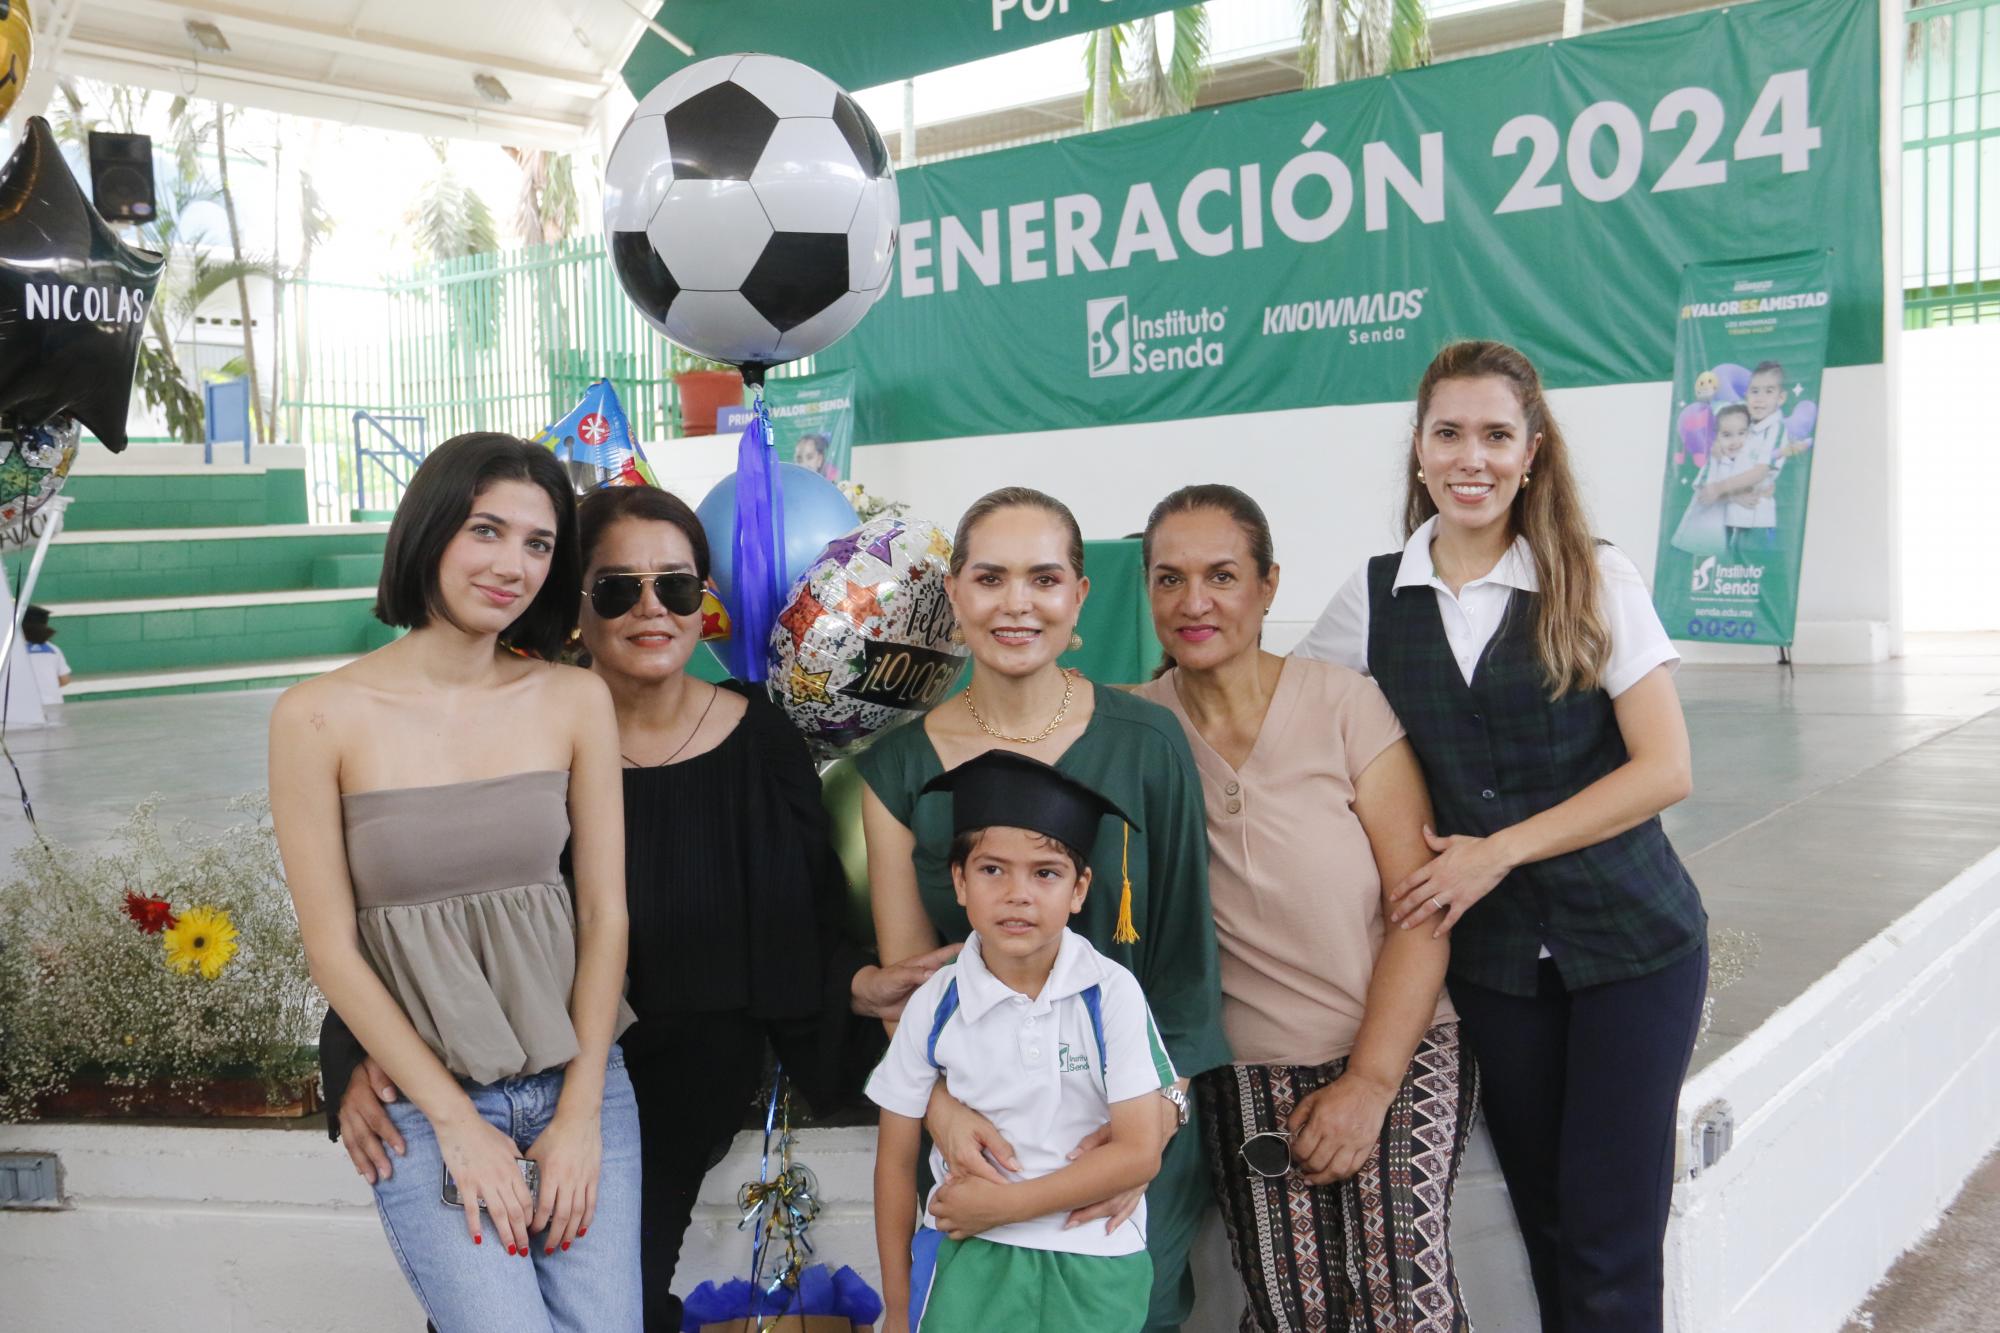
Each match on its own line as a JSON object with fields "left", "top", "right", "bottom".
{"left": 270, "top": 434, "right": 642, "bottom": 1333}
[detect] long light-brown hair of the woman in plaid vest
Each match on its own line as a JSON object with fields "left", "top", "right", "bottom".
{"left": 1402, "top": 340, "right": 1612, "bottom": 699}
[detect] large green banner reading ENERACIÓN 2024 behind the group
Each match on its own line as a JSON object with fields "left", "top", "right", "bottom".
{"left": 816, "top": 0, "right": 1882, "bottom": 444}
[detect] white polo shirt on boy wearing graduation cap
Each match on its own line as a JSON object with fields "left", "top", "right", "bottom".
{"left": 868, "top": 931, "right": 1178, "bottom": 1255}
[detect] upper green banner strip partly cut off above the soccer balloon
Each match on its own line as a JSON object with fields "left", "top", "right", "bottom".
{"left": 624, "top": 0, "right": 1188, "bottom": 98}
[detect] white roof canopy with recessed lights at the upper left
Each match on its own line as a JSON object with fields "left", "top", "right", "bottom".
{"left": 47, "top": 0, "right": 658, "bottom": 148}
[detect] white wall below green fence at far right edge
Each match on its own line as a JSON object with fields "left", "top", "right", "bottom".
{"left": 1898, "top": 324, "right": 2000, "bottom": 630}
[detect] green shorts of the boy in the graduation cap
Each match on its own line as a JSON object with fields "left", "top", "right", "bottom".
{"left": 912, "top": 1227, "right": 1152, "bottom": 1333}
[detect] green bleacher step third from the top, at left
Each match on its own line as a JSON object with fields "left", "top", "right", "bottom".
{"left": 44, "top": 588, "right": 394, "bottom": 677}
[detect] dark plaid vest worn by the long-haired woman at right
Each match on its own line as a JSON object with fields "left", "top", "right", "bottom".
{"left": 1368, "top": 552, "right": 1708, "bottom": 995}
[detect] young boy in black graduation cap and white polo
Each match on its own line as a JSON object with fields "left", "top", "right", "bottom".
{"left": 868, "top": 751, "right": 1176, "bottom": 1333}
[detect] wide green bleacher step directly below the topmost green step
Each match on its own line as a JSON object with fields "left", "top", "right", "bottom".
{"left": 6, "top": 524, "right": 388, "bottom": 604}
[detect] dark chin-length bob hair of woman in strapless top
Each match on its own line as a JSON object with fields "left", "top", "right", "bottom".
{"left": 374, "top": 430, "right": 584, "bottom": 662}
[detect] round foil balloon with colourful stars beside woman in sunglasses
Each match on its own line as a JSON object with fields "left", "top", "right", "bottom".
{"left": 766, "top": 518, "right": 966, "bottom": 759}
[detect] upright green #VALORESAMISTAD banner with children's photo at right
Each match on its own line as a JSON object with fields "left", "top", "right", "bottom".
{"left": 1652, "top": 250, "right": 1830, "bottom": 644}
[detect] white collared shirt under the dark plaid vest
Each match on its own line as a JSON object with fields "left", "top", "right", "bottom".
{"left": 1292, "top": 514, "right": 1680, "bottom": 699}
